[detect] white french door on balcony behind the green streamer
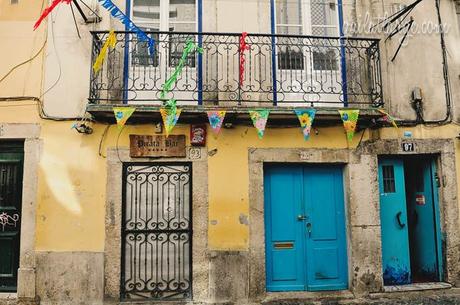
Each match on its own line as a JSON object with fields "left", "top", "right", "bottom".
{"left": 125, "top": 0, "right": 198, "bottom": 104}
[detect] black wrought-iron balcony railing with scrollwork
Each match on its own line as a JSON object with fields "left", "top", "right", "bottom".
{"left": 89, "top": 32, "right": 383, "bottom": 108}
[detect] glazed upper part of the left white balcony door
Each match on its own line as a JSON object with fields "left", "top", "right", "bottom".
{"left": 131, "top": 0, "right": 199, "bottom": 67}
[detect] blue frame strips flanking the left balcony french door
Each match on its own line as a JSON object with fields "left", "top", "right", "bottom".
{"left": 123, "top": 0, "right": 203, "bottom": 105}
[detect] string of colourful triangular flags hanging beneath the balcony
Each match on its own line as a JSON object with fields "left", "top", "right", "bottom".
{"left": 113, "top": 105, "right": 397, "bottom": 142}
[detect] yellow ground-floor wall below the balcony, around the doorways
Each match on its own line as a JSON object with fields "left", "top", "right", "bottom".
{"left": 0, "top": 102, "right": 460, "bottom": 251}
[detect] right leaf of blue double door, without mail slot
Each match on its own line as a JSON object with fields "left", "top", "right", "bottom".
{"left": 304, "top": 166, "right": 347, "bottom": 291}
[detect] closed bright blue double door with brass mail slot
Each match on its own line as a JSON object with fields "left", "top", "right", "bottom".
{"left": 264, "top": 165, "right": 348, "bottom": 291}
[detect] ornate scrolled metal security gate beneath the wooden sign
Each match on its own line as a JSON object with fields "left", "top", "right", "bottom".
{"left": 121, "top": 163, "right": 192, "bottom": 300}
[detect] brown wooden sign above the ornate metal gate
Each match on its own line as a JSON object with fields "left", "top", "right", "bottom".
{"left": 129, "top": 135, "right": 186, "bottom": 158}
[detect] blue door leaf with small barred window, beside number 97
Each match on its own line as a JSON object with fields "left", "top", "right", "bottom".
{"left": 379, "top": 159, "right": 411, "bottom": 285}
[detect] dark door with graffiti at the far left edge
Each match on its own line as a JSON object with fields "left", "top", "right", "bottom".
{"left": 0, "top": 144, "right": 24, "bottom": 292}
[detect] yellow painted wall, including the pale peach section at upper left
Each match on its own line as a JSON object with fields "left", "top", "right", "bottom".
{"left": 0, "top": 0, "right": 460, "bottom": 251}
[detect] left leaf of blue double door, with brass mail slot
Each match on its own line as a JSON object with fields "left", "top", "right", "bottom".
{"left": 265, "top": 167, "right": 305, "bottom": 291}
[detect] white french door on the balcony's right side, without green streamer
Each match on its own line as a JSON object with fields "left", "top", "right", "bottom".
{"left": 273, "top": 0, "right": 344, "bottom": 107}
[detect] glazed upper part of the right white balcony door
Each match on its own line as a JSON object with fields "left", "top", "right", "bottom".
{"left": 274, "top": 0, "right": 339, "bottom": 70}
